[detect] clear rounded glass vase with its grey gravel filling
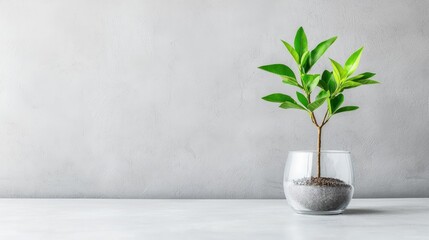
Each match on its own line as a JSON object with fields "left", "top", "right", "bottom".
{"left": 283, "top": 151, "right": 354, "bottom": 214}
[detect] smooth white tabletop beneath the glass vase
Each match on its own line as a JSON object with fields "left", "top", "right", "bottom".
{"left": 0, "top": 199, "right": 429, "bottom": 240}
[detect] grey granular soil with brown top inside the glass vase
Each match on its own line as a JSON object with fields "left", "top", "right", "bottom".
{"left": 285, "top": 177, "right": 353, "bottom": 212}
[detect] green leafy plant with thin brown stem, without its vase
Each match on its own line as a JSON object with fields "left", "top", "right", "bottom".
{"left": 259, "top": 27, "right": 378, "bottom": 178}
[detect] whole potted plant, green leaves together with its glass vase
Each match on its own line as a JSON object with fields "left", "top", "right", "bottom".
{"left": 259, "top": 27, "right": 378, "bottom": 214}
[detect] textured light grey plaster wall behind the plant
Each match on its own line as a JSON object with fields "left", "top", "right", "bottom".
{"left": 0, "top": 0, "right": 429, "bottom": 198}
